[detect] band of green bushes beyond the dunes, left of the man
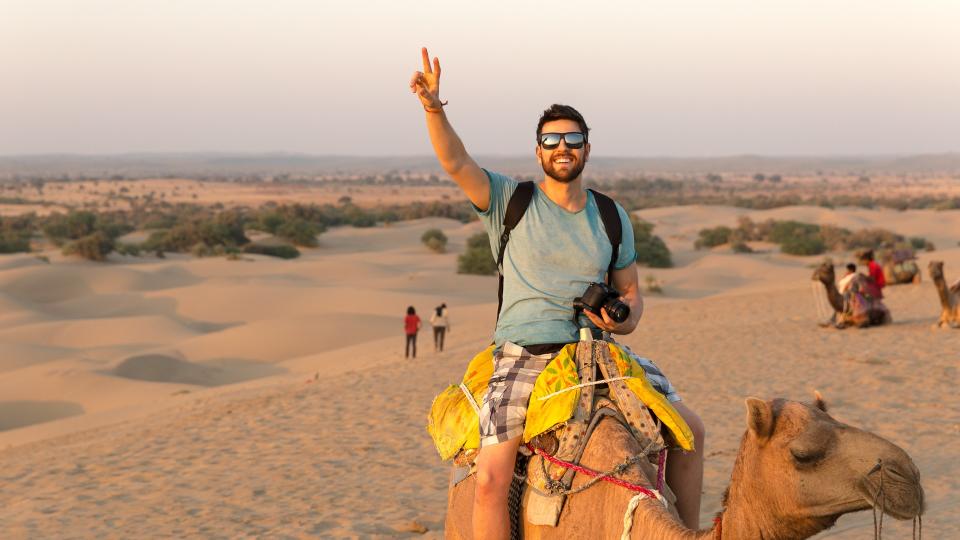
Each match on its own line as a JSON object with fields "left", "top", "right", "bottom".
{"left": 0, "top": 198, "right": 476, "bottom": 261}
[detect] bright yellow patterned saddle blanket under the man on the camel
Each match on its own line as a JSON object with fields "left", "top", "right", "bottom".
{"left": 427, "top": 343, "right": 693, "bottom": 460}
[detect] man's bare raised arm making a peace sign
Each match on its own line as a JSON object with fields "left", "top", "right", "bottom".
{"left": 410, "top": 47, "right": 490, "bottom": 210}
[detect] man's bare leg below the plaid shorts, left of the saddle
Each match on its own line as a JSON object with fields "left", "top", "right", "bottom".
{"left": 473, "top": 437, "right": 521, "bottom": 540}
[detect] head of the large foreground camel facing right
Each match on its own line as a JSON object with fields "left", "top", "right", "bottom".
{"left": 731, "top": 395, "right": 923, "bottom": 534}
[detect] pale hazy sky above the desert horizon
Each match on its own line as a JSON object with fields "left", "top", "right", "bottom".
{"left": 0, "top": 0, "right": 960, "bottom": 156}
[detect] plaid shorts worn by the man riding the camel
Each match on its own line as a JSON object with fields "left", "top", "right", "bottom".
{"left": 480, "top": 341, "right": 680, "bottom": 447}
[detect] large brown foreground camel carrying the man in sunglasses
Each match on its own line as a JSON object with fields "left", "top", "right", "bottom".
{"left": 446, "top": 398, "right": 923, "bottom": 540}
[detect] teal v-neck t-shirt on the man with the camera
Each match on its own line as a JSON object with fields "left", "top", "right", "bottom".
{"left": 475, "top": 171, "right": 637, "bottom": 346}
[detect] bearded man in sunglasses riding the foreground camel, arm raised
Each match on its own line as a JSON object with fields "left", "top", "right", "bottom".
{"left": 410, "top": 48, "right": 704, "bottom": 539}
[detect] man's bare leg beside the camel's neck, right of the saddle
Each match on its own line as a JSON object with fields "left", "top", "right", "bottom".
{"left": 667, "top": 401, "right": 706, "bottom": 530}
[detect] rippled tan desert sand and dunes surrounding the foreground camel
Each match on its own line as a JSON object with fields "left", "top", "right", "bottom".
{"left": 0, "top": 206, "right": 960, "bottom": 538}
